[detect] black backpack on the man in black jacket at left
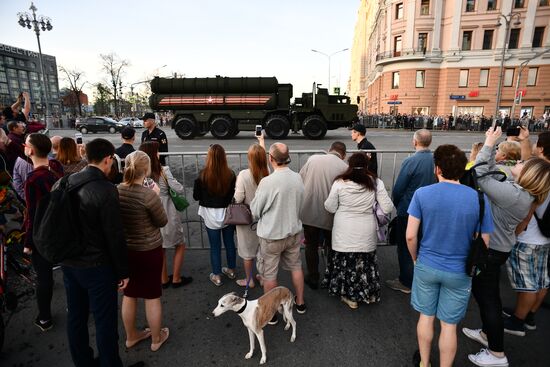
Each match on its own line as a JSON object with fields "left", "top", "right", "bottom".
{"left": 32, "top": 176, "right": 96, "bottom": 264}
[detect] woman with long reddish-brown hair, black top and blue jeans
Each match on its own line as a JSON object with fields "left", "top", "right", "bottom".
{"left": 193, "top": 144, "right": 237, "bottom": 286}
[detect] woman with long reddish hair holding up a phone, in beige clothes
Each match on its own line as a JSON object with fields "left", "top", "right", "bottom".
{"left": 234, "top": 136, "right": 269, "bottom": 288}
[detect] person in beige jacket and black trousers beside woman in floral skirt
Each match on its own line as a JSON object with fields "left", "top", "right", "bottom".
{"left": 300, "top": 141, "right": 348, "bottom": 289}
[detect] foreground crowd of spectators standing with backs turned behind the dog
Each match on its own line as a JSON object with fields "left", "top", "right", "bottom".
{"left": 0, "top": 92, "right": 550, "bottom": 367}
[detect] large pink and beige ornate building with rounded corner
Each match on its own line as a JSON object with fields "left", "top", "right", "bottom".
{"left": 350, "top": 0, "right": 550, "bottom": 118}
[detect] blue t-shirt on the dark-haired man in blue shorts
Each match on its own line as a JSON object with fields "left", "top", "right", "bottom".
{"left": 408, "top": 182, "right": 493, "bottom": 273}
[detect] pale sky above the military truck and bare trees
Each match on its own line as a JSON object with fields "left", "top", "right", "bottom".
{"left": 0, "top": 0, "right": 360, "bottom": 102}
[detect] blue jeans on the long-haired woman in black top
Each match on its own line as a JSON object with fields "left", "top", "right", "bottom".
{"left": 206, "top": 226, "right": 237, "bottom": 275}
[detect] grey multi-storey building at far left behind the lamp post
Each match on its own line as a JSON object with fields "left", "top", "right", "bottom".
{"left": 0, "top": 43, "right": 61, "bottom": 116}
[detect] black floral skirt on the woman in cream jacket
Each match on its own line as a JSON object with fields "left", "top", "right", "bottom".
{"left": 321, "top": 251, "right": 380, "bottom": 303}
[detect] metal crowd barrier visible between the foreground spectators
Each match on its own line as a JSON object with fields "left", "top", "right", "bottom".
{"left": 161, "top": 150, "right": 414, "bottom": 249}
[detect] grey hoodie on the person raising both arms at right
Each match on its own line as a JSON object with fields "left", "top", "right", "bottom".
{"left": 476, "top": 145, "right": 534, "bottom": 252}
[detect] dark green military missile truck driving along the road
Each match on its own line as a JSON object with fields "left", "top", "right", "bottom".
{"left": 149, "top": 76, "right": 357, "bottom": 139}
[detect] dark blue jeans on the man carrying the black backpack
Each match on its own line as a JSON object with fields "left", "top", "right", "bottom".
{"left": 63, "top": 266, "right": 122, "bottom": 367}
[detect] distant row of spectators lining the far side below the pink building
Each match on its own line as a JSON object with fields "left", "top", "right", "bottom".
{"left": 358, "top": 111, "right": 550, "bottom": 132}
